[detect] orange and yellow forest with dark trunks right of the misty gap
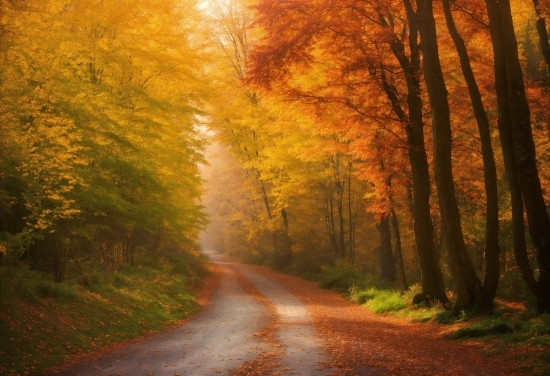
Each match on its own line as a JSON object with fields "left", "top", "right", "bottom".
{"left": 203, "top": 0, "right": 550, "bottom": 318}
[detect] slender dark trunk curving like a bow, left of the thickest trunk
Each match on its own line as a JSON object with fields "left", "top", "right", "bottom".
{"left": 443, "top": 0, "right": 500, "bottom": 311}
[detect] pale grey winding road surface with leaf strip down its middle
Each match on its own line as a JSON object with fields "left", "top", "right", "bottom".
{"left": 53, "top": 253, "right": 329, "bottom": 376}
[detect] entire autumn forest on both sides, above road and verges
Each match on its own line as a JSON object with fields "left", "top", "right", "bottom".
{"left": 0, "top": 0, "right": 550, "bottom": 368}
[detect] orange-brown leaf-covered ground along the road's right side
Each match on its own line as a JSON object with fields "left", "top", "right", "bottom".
{"left": 249, "top": 266, "right": 522, "bottom": 376}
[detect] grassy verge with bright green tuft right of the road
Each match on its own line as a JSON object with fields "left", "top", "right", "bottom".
{"left": 349, "top": 286, "right": 550, "bottom": 376}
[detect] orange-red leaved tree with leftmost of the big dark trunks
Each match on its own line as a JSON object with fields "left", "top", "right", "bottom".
{"left": 250, "top": 1, "right": 448, "bottom": 303}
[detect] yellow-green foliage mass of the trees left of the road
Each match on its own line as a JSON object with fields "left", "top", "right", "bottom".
{"left": 0, "top": 0, "right": 208, "bottom": 268}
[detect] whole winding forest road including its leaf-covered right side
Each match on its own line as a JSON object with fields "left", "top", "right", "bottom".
{"left": 51, "top": 252, "right": 524, "bottom": 376}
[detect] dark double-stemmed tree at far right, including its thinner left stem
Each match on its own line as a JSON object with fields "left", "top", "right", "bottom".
{"left": 485, "top": 0, "right": 550, "bottom": 312}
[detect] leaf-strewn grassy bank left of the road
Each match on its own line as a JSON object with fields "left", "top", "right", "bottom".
{"left": 0, "top": 260, "right": 209, "bottom": 375}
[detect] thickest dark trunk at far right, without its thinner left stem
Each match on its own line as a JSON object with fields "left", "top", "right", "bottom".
{"left": 485, "top": 0, "right": 550, "bottom": 312}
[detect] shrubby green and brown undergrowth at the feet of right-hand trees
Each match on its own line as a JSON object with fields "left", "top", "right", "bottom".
{"left": 319, "top": 263, "right": 550, "bottom": 375}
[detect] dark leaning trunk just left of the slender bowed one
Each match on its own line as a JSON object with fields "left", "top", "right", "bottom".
{"left": 417, "top": 0, "right": 482, "bottom": 311}
